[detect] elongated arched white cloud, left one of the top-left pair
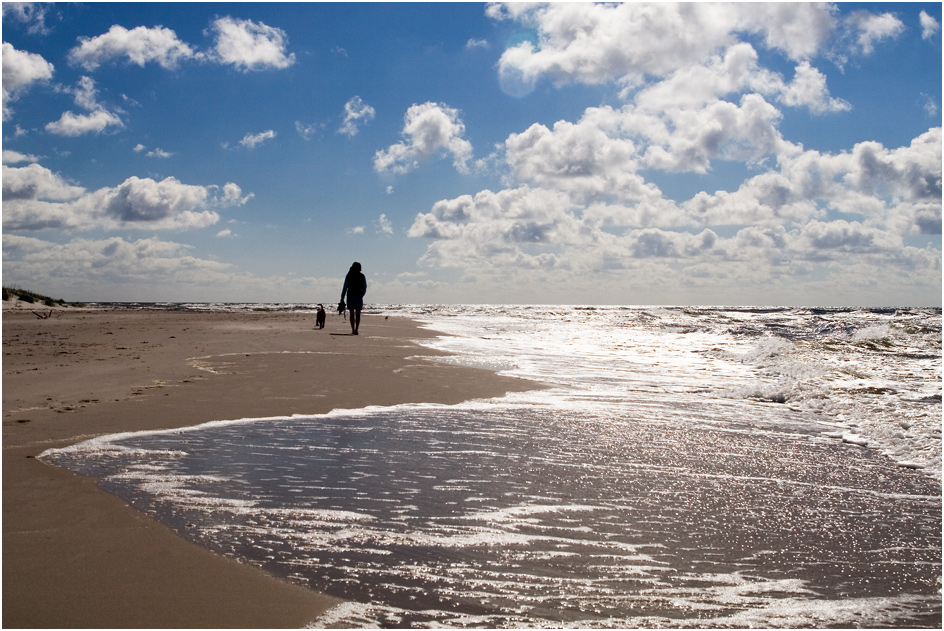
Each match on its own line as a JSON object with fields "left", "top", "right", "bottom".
{"left": 69, "top": 24, "right": 199, "bottom": 71}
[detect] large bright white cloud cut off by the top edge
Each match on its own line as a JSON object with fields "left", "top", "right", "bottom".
{"left": 488, "top": 3, "right": 834, "bottom": 95}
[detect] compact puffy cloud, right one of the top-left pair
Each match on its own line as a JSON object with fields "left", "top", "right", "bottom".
{"left": 210, "top": 17, "right": 295, "bottom": 71}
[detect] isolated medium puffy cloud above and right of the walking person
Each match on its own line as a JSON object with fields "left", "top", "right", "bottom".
{"left": 374, "top": 102, "right": 472, "bottom": 174}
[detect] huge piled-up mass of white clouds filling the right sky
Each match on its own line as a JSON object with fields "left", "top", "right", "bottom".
{"left": 398, "top": 3, "right": 941, "bottom": 300}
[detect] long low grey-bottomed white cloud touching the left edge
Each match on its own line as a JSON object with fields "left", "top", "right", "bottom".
{"left": 3, "top": 164, "right": 252, "bottom": 231}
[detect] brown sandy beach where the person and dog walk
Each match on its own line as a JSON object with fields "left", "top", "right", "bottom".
{"left": 3, "top": 308, "right": 534, "bottom": 628}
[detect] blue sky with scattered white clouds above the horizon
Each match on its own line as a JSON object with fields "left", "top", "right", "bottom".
{"left": 2, "top": 2, "right": 942, "bottom": 307}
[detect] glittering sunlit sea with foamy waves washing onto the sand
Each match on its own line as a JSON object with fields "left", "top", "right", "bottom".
{"left": 41, "top": 305, "right": 942, "bottom": 628}
